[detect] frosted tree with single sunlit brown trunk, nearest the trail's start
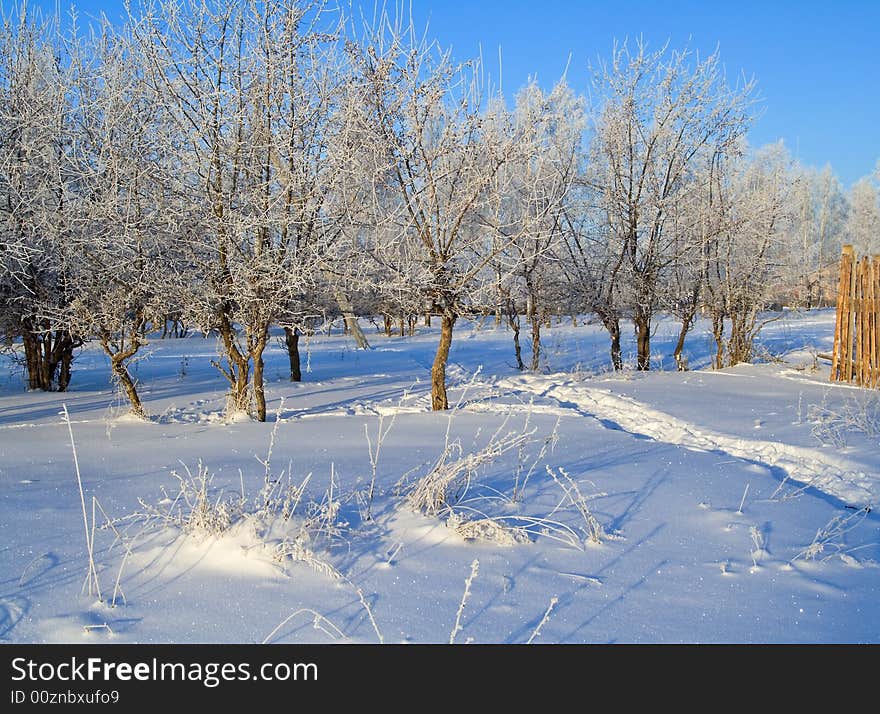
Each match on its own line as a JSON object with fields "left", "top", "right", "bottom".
{"left": 353, "top": 13, "right": 522, "bottom": 410}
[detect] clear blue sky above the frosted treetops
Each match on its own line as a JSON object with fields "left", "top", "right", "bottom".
{"left": 8, "top": 0, "right": 880, "bottom": 186}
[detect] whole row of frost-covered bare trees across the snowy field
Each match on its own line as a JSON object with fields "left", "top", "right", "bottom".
{"left": 0, "top": 0, "right": 880, "bottom": 420}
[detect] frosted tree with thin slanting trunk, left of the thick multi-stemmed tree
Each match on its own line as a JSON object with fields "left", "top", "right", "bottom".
{"left": 57, "top": 26, "right": 177, "bottom": 417}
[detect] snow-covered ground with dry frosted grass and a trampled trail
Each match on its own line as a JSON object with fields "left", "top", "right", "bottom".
{"left": 0, "top": 310, "right": 880, "bottom": 643}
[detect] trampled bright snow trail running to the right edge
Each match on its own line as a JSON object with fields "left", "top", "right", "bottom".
{"left": 494, "top": 375, "right": 878, "bottom": 508}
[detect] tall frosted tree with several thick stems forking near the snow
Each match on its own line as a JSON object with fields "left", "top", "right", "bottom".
{"left": 134, "top": 0, "right": 337, "bottom": 421}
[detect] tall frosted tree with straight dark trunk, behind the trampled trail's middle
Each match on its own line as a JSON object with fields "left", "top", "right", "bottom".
{"left": 590, "top": 43, "right": 752, "bottom": 370}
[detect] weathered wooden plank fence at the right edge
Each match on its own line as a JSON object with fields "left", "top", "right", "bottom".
{"left": 831, "top": 245, "right": 880, "bottom": 388}
